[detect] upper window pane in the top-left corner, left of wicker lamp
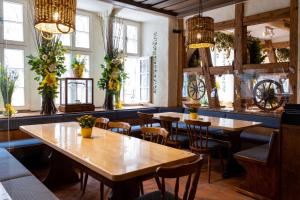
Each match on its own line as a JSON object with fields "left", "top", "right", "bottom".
{"left": 3, "top": 1, "right": 24, "bottom": 42}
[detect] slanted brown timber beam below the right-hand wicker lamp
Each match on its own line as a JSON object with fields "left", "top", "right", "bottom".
{"left": 199, "top": 48, "right": 220, "bottom": 108}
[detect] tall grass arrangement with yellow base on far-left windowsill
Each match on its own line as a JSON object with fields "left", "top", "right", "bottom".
{"left": 0, "top": 64, "right": 18, "bottom": 117}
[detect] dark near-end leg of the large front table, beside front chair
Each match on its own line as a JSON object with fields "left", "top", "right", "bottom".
{"left": 109, "top": 179, "right": 140, "bottom": 200}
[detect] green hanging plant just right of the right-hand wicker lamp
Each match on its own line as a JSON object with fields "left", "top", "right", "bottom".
{"left": 215, "top": 32, "right": 234, "bottom": 58}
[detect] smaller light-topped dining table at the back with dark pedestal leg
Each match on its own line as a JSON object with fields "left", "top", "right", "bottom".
{"left": 153, "top": 112, "right": 262, "bottom": 178}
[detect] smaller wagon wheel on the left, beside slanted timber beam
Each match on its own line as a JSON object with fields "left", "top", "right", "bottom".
{"left": 188, "top": 78, "right": 205, "bottom": 100}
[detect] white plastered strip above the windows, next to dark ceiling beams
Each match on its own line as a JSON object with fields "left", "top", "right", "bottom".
{"left": 77, "top": 0, "right": 164, "bottom": 22}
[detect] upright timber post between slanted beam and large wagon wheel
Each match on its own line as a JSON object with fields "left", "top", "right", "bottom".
{"left": 233, "top": 3, "right": 247, "bottom": 110}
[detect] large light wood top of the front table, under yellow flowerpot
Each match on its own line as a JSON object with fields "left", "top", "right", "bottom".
{"left": 20, "top": 122, "right": 196, "bottom": 181}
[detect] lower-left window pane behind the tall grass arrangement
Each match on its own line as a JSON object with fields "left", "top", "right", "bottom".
{"left": 4, "top": 48, "right": 25, "bottom": 106}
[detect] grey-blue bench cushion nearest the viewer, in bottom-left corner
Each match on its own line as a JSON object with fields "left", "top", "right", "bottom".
{"left": 2, "top": 175, "right": 58, "bottom": 200}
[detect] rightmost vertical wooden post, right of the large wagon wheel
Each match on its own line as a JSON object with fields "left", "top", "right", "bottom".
{"left": 289, "top": 0, "right": 298, "bottom": 103}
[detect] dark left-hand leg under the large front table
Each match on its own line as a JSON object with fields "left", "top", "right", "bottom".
{"left": 43, "top": 150, "right": 79, "bottom": 188}
